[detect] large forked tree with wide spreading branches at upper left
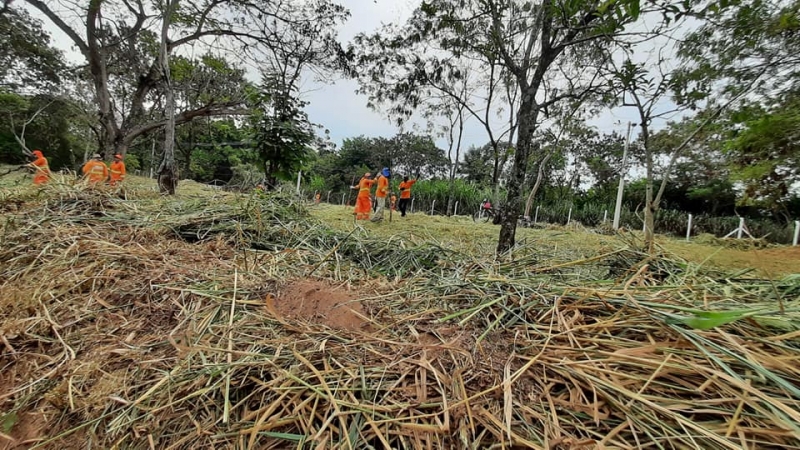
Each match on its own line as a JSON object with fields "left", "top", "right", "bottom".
{"left": 25, "top": 0, "right": 347, "bottom": 160}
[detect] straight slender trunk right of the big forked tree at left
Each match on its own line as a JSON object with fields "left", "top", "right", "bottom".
{"left": 158, "top": 0, "right": 178, "bottom": 195}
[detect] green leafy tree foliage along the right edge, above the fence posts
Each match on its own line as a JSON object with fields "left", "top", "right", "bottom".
{"left": 679, "top": 0, "right": 800, "bottom": 219}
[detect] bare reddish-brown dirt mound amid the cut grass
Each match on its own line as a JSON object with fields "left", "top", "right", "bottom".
{"left": 271, "top": 280, "right": 368, "bottom": 331}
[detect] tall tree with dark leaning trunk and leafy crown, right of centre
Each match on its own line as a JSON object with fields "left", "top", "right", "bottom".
{"left": 354, "top": 0, "right": 640, "bottom": 255}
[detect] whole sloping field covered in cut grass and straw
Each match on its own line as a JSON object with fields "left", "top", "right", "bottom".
{"left": 0, "top": 170, "right": 800, "bottom": 449}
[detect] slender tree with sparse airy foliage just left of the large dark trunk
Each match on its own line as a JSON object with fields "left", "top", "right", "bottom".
{"left": 351, "top": 2, "right": 519, "bottom": 201}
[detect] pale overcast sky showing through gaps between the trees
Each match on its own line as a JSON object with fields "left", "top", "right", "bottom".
{"left": 28, "top": 0, "right": 672, "bottom": 154}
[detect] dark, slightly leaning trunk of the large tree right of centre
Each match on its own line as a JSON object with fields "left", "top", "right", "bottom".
{"left": 497, "top": 95, "right": 539, "bottom": 256}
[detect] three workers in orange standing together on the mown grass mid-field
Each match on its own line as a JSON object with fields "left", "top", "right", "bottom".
{"left": 350, "top": 167, "right": 417, "bottom": 222}
